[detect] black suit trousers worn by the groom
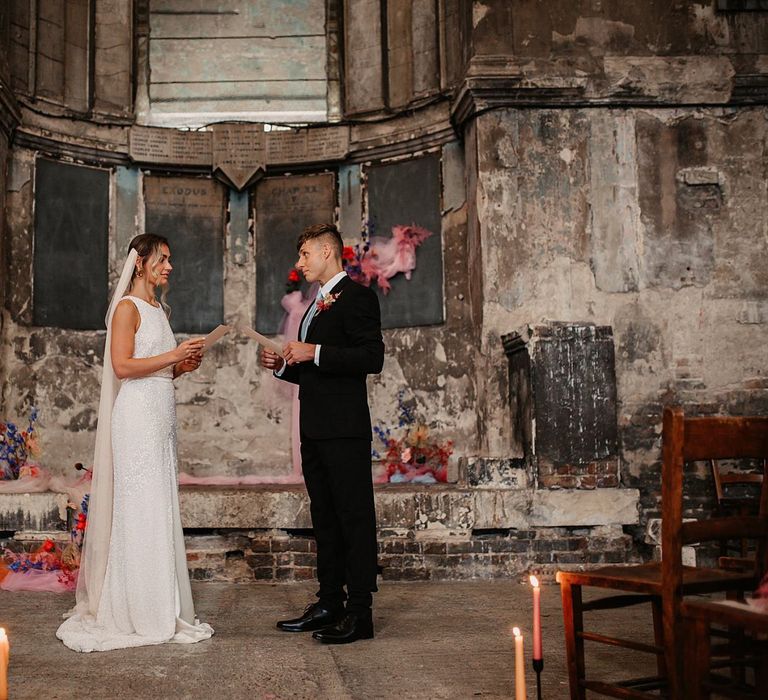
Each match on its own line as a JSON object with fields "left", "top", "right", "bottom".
{"left": 301, "top": 436, "right": 377, "bottom": 611}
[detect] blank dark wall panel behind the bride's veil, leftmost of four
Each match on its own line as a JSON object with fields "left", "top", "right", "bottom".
{"left": 33, "top": 158, "right": 109, "bottom": 330}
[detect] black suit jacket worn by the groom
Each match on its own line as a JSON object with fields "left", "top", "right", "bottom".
{"left": 280, "top": 277, "right": 384, "bottom": 440}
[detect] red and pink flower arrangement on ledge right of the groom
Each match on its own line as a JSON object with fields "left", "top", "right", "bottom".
{"left": 372, "top": 389, "right": 453, "bottom": 484}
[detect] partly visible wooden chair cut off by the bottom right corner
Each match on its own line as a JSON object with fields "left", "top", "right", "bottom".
{"left": 680, "top": 601, "right": 768, "bottom": 700}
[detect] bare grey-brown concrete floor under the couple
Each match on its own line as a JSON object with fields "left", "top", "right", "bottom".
{"left": 0, "top": 581, "right": 654, "bottom": 700}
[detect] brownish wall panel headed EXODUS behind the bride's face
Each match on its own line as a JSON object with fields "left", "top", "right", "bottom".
{"left": 144, "top": 177, "right": 225, "bottom": 333}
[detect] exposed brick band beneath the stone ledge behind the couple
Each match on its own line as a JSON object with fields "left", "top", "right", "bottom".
{"left": 180, "top": 526, "right": 638, "bottom": 581}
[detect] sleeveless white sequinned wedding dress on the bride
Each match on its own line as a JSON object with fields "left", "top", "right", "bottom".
{"left": 56, "top": 296, "right": 213, "bottom": 652}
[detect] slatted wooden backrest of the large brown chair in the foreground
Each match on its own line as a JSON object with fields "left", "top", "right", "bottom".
{"left": 661, "top": 408, "right": 768, "bottom": 585}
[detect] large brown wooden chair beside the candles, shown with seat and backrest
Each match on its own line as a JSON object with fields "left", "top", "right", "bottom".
{"left": 557, "top": 408, "right": 768, "bottom": 700}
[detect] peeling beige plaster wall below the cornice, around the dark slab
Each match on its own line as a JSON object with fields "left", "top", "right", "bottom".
{"left": 470, "top": 102, "right": 768, "bottom": 520}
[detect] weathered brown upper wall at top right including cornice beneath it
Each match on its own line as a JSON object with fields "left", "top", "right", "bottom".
{"left": 452, "top": 0, "right": 768, "bottom": 123}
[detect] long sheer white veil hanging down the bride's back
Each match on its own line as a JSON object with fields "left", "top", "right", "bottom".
{"left": 72, "top": 248, "right": 138, "bottom": 618}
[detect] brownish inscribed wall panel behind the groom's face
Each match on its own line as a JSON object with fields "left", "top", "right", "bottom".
{"left": 255, "top": 173, "right": 336, "bottom": 334}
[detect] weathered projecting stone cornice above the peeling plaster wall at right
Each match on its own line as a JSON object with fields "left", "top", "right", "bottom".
{"left": 451, "top": 55, "right": 768, "bottom": 127}
